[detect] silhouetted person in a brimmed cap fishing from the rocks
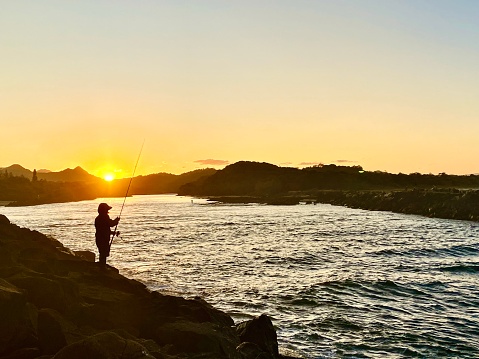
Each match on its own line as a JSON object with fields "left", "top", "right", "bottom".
{"left": 95, "top": 203, "right": 120, "bottom": 268}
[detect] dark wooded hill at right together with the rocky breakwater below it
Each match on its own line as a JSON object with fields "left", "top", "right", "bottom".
{"left": 179, "top": 162, "right": 479, "bottom": 221}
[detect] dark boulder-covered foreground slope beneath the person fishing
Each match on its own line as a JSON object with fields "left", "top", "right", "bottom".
{"left": 0, "top": 215, "right": 298, "bottom": 359}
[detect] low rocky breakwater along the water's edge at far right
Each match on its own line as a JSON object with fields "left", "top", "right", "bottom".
{"left": 209, "top": 188, "right": 479, "bottom": 222}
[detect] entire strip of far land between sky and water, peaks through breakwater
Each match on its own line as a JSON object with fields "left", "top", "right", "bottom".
{"left": 0, "top": 161, "right": 479, "bottom": 220}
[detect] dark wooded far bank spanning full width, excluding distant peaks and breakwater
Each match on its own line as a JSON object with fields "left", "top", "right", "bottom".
{"left": 0, "top": 161, "right": 479, "bottom": 205}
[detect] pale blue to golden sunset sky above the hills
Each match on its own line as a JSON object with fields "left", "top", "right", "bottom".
{"left": 0, "top": 0, "right": 479, "bottom": 177}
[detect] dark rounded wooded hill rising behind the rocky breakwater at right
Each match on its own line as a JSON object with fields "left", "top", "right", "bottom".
{"left": 178, "top": 161, "right": 479, "bottom": 196}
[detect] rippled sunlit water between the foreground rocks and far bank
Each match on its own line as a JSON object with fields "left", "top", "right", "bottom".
{"left": 0, "top": 195, "right": 479, "bottom": 358}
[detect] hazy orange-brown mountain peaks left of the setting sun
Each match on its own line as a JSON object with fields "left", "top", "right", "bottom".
{"left": 0, "top": 164, "right": 101, "bottom": 182}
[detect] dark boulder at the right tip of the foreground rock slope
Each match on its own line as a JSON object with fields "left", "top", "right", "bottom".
{"left": 236, "top": 314, "right": 279, "bottom": 358}
